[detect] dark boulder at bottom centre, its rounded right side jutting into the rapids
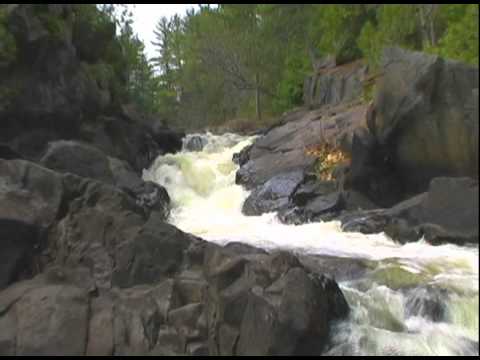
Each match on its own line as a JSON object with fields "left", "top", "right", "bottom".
{"left": 205, "top": 248, "right": 348, "bottom": 355}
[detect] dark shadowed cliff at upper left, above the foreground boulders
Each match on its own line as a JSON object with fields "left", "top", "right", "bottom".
{"left": 0, "top": 4, "right": 184, "bottom": 171}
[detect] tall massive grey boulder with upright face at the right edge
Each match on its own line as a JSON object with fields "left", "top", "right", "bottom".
{"left": 369, "top": 48, "right": 479, "bottom": 192}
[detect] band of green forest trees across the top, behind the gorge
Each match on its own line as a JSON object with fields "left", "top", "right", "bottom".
{"left": 0, "top": 4, "right": 478, "bottom": 129}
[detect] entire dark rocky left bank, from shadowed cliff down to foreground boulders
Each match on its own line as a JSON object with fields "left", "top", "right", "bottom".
{"left": 0, "top": 5, "right": 349, "bottom": 355}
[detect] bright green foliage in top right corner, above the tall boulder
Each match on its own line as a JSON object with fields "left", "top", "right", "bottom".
{"left": 357, "top": 4, "right": 478, "bottom": 67}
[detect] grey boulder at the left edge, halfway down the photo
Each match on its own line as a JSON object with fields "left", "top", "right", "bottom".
{"left": 0, "top": 160, "right": 64, "bottom": 289}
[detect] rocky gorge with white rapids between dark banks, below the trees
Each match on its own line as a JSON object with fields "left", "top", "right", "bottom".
{"left": 0, "top": 4, "right": 479, "bottom": 356}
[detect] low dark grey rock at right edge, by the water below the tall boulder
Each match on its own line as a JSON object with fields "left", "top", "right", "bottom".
{"left": 342, "top": 178, "right": 479, "bottom": 244}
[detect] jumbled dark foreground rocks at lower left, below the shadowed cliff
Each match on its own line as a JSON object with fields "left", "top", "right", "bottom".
{"left": 0, "top": 160, "right": 349, "bottom": 355}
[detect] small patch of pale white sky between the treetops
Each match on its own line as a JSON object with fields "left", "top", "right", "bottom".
{"left": 128, "top": 4, "right": 197, "bottom": 59}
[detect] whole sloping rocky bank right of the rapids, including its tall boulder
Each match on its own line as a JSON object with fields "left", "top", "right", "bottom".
{"left": 236, "top": 48, "right": 479, "bottom": 233}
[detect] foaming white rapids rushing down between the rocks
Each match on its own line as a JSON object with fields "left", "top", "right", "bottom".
{"left": 144, "top": 134, "right": 479, "bottom": 355}
